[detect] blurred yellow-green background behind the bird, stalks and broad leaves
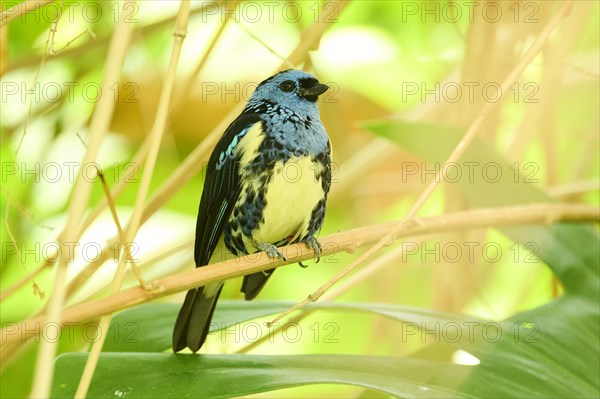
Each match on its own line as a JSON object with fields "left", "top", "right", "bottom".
{"left": 0, "top": 1, "right": 600, "bottom": 397}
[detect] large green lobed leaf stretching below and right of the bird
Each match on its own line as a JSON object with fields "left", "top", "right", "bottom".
{"left": 53, "top": 122, "right": 600, "bottom": 398}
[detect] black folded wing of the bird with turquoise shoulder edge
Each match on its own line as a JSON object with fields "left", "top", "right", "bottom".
{"left": 194, "top": 113, "right": 261, "bottom": 267}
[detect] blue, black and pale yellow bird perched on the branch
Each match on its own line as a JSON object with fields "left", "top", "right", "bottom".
{"left": 173, "top": 70, "right": 331, "bottom": 352}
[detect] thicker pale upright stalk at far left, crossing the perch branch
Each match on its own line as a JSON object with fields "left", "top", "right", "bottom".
{"left": 30, "top": 0, "right": 138, "bottom": 398}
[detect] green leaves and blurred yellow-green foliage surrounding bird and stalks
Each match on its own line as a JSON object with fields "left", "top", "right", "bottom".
{"left": 0, "top": 0, "right": 600, "bottom": 398}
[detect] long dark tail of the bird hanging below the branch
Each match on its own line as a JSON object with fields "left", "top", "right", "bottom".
{"left": 173, "top": 282, "right": 223, "bottom": 352}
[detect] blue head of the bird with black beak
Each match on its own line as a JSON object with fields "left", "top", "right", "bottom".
{"left": 250, "top": 69, "right": 329, "bottom": 109}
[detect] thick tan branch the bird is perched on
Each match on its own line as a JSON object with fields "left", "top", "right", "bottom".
{"left": 0, "top": 203, "right": 600, "bottom": 350}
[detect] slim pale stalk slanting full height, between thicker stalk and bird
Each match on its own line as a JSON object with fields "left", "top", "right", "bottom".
{"left": 75, "top": 0, "right": 190, "bottom": 398}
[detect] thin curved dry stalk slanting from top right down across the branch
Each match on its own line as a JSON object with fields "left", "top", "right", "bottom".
{"left": 271, "top": 0, "right": 573, "bottom": 324}
